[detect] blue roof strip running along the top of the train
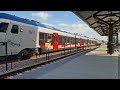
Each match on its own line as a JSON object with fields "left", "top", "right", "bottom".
{"left": 0, "top": 13, "right": 79, "bottom": 36}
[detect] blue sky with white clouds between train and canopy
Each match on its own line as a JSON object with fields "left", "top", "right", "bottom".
{"left": 0, "top": 11, "right": 107, "bottom": 41}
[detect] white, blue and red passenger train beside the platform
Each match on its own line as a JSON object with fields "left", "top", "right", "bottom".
{"left": 0, "top": 13, "right": 97, "bottom": 58}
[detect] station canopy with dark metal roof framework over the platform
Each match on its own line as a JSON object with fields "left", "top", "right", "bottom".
{"left": 73, "top": 11, "right": 120, "bottom": 36}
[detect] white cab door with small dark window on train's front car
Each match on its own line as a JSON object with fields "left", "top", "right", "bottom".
{"left": 6, "top": 23, "right": 21, "bottom": 55}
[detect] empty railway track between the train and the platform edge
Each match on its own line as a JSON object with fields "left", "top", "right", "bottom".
{"left": 0, "top": 45, "right": 96, "bottom": 79}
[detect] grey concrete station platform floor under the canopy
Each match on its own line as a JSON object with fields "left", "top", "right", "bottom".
{"left": 10, "top": 45, "right": 118, "bottom": 79}
